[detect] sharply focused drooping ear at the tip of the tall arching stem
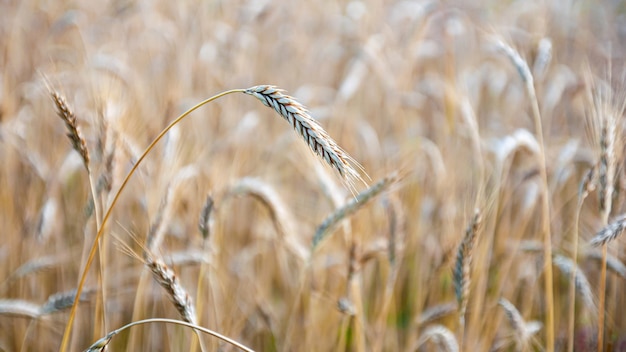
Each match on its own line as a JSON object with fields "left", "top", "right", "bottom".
{"left": 245, "top": 85, "right": 367, "bottom": 189}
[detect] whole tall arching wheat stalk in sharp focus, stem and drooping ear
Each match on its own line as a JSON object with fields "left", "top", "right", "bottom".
{"left": 60, "top": 85, "right": 364, "bottom": 351}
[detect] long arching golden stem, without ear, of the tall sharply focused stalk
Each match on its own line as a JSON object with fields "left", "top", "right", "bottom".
{"left": 60, "top": 89, "right": 245, "bottom": 352}
